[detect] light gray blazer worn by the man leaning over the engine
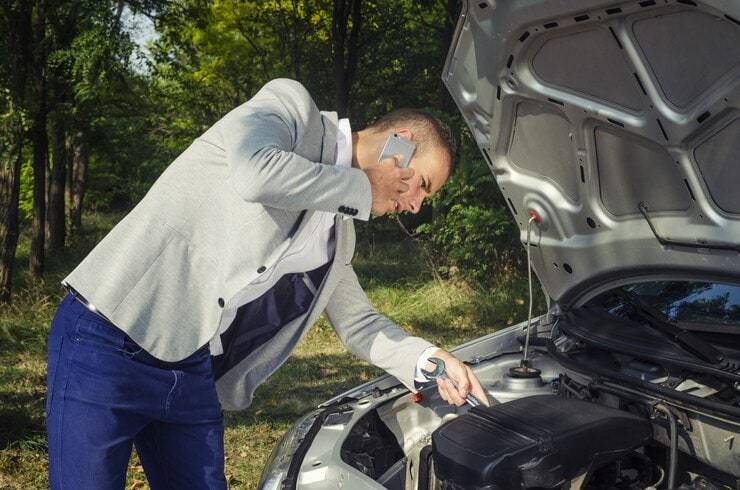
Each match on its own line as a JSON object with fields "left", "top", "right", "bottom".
{"left": 64, "top": 79, "right": 431, "bottom": 410}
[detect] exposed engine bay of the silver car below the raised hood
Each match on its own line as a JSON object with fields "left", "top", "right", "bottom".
{"left": 283, "top": 308, "right": 740, "bottom": 490}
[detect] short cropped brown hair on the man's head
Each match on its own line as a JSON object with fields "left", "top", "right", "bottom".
{"left": 370, "top": 109, "right": 457, "bottom": 164}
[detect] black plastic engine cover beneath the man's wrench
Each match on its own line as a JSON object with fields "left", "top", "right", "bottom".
{"left": 432, "top": 395, "right": 652, "bottom": 490}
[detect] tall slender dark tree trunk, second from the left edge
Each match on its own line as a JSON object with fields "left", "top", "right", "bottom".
{"left": 28, "top": 0, "right": 49, "bottom": 278}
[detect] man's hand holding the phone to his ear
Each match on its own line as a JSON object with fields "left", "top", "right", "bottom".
{"left": 363, "top": 156, "right": 414, "bottom": 216}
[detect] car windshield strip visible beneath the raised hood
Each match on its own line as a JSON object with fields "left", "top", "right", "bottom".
{"left": 592, "top": 281, "right": 740, "bottom": 327}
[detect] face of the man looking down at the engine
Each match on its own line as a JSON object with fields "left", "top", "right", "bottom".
{"left": 394, "top": 146, "right": 451, "bottom": 214}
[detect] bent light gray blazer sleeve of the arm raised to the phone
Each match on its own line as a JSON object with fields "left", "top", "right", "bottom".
{"left": 224, "top": 79, "right": 372, "bottom": 220}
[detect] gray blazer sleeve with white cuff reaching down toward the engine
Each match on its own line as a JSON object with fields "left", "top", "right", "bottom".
{"left": 324, "top": 265, "right": 434, "bottom": 392}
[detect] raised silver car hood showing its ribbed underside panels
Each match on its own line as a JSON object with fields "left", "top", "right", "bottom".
{"left": 443, "top": 0, "right": 740, "bottom": 305}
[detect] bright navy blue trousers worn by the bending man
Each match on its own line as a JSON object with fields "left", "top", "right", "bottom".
{"left": 46, "top": 296, "right": 226, "bottom": 490}
